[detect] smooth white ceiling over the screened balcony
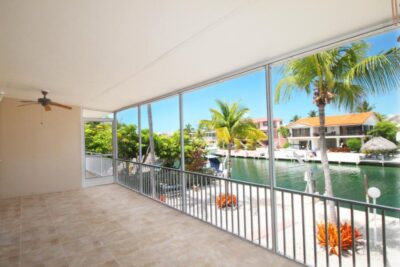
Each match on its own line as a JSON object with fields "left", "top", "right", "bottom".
{"left": 0, "top": 0, "right": 391, "bottom": 111}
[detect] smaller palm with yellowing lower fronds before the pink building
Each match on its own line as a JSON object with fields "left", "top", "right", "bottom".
{"left": 200, "top": 100, "right": 267, "bottom": 178}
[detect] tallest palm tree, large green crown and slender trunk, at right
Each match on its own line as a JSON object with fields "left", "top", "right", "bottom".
{"left": 275, "top": 41, "right": 400, "bottom": 222}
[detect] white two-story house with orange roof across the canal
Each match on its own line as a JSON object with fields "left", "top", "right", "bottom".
{"left": 287, "top": 112, "right": 378, "bottom": 150}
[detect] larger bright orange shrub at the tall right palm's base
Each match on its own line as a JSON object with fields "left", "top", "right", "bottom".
{"left": 317, "top": 223, "right": 362, "bottom": 255}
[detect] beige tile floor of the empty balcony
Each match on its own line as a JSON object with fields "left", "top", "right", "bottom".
{"left": 0, "top": 185, "right": 297, "bottom": 267}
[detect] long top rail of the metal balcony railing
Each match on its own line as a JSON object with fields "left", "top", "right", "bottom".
{"left": 116, "top": 159, "right": 400, "bottom": 212}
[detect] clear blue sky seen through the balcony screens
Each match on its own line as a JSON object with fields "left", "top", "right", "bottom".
{"left": 117, "top": 29, "right": 400, "bottom": 133}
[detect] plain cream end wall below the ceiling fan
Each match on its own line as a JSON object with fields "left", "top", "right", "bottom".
{"left": 0, "top": 98, "right": 82, "bottom": 198}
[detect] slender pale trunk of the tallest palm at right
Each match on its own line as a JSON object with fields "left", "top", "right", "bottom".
{"left": 318, "top": 105, "right": 336, "bottom": 223}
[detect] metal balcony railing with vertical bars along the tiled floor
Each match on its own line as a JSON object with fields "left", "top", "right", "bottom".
{"left": 116, "top": 160, "right": 400, "bottom": 266}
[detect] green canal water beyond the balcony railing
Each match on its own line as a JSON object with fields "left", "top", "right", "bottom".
{"left": 228, "top": 158, "right": 400, "bottom": 208}
